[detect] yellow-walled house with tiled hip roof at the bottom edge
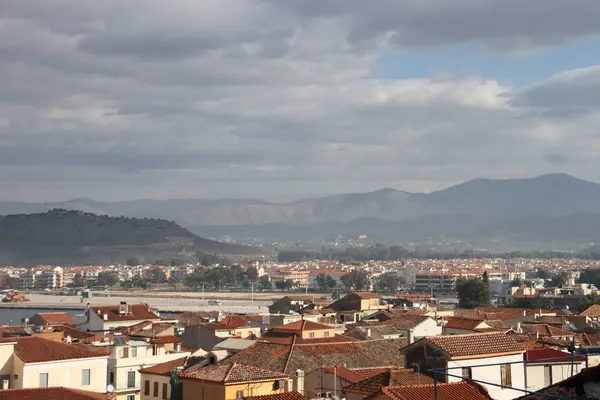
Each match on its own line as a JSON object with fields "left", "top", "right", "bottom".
{"left": 180, "top": 362, "right": 292, "bottom": 400}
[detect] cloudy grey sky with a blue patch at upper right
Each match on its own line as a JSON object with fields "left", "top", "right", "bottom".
{"left": 0, "top": 0, "right": 600, "bottom": 201}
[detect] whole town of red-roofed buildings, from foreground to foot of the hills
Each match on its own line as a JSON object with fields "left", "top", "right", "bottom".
{"left": 0, "top": 259, "right": 600, "bottom": 400}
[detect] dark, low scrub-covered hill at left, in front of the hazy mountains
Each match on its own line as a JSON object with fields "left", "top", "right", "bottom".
{"left": 0, "top": 209, "right": 260, "bottom": 265}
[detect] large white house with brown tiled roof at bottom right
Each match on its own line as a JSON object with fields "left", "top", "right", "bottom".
{"left": 403, "top": 333, "right": 525, "bottom": 400}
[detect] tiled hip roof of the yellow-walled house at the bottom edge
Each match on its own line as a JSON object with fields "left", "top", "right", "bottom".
{"left": 181, "top": 362, "right": 288, "bottom": 383}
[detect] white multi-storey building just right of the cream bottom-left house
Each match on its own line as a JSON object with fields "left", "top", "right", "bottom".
{"left": 108, "top": 336, "right": 190, "bottom": 400}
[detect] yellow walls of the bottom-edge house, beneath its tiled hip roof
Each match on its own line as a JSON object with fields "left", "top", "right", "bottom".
{"left": 183, "top": 379, "right": 287, "bottom": 400}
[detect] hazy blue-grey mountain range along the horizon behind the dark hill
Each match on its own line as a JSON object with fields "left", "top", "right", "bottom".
{"left": 0, "top": 173, "right": 600, "bottom": 247}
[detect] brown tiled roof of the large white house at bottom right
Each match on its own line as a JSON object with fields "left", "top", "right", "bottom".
{"left": 413, "top": 333, "right": 525, "bottom": 358}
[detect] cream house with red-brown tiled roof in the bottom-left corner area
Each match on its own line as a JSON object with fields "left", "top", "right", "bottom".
{"left": 10, "top": 337, "right": 108, "bottom": 393}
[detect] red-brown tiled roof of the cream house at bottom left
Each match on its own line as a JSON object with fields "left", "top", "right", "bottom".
{"left": 15, "top": 336, "right": 106, "bottom": 363}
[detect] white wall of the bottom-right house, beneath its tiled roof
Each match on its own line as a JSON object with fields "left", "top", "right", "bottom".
{"left": 447, "top": 354, "right": 525, "bottom": 400}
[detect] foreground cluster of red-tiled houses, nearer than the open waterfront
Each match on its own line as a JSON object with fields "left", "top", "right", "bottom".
{"left": 0, "top": 292, "right": 600, "bottom": 400}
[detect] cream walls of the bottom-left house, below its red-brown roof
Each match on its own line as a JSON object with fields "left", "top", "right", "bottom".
{"left": 13, "top": 356, "right": 107, "bottom": 393}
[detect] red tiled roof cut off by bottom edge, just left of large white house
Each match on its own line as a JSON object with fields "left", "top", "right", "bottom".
{"left": 367, "top": 381, "right": 492, "bottom": 400}
